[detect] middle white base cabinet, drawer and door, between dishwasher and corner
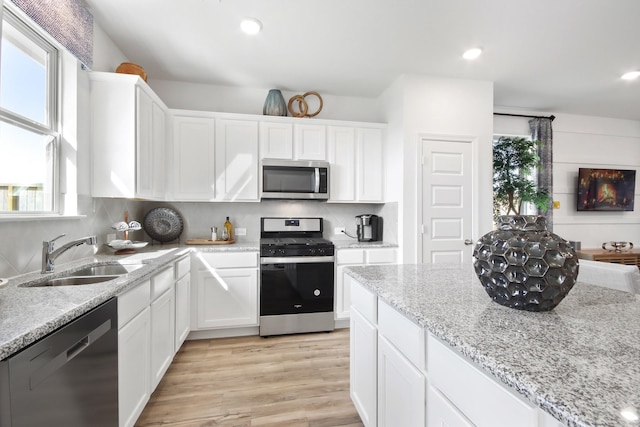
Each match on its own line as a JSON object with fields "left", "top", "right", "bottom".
{"left": 150, "top": 267, "right": 175, "bottom": 393}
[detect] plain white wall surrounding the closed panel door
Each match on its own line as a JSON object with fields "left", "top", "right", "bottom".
{"left": 382, "top": 75, "right": 493, "bottom": 263}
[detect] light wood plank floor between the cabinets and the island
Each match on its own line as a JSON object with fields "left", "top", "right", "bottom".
{"left": 136, "top": 329, "right": 363, "bottom": 427}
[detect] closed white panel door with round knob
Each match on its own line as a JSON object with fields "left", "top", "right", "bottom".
{"left": 419, "top": 138, "right": 473, "bottom": 264}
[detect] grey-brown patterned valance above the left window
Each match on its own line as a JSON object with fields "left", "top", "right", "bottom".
{"left": 11, "top": 0, "right": 93, "bottom": 68}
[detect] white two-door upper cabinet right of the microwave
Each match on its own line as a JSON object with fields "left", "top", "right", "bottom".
{"left": 327, "top": 126, "right": 384, "bottom": 203}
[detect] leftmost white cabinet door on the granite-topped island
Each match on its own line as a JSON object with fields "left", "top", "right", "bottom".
{"left": 349, "top": 304, "right": 378, "bottom": 427}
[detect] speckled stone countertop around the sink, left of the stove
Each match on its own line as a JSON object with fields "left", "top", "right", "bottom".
{"left": 0, "top": 241, "right": 259, "bottom": 360}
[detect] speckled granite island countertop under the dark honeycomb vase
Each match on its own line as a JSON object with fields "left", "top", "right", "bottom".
{"left": 345, "top": 264, "right": 640, "bottom": 426}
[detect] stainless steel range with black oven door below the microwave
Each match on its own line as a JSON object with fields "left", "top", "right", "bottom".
{"left": 260, "top": 218, "right": 334, "bottom": 336}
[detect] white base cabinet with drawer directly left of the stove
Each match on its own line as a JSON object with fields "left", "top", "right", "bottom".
{"left": 192, "top": 252, "right": 258, "bottom": 330}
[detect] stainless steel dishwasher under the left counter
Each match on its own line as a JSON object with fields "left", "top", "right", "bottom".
{"left": 0, "top": 298, "right": 118, "bottom": 427}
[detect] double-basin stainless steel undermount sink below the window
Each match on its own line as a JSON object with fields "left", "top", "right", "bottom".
{"left": 19, "top": 264, "right": 144, "bottom": 288}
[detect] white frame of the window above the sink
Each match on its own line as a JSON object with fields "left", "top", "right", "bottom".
{"left": 0, "top": 4, "right": 63, "bottom": 219}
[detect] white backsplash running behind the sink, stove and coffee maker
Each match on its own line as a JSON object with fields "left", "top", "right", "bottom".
{"left": 0, "top": 196, "right": 398, "bottom": 278}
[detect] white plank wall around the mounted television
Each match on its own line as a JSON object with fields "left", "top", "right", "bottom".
{"left": 494, "top": 109, "right": 640, "bottom": 249}
